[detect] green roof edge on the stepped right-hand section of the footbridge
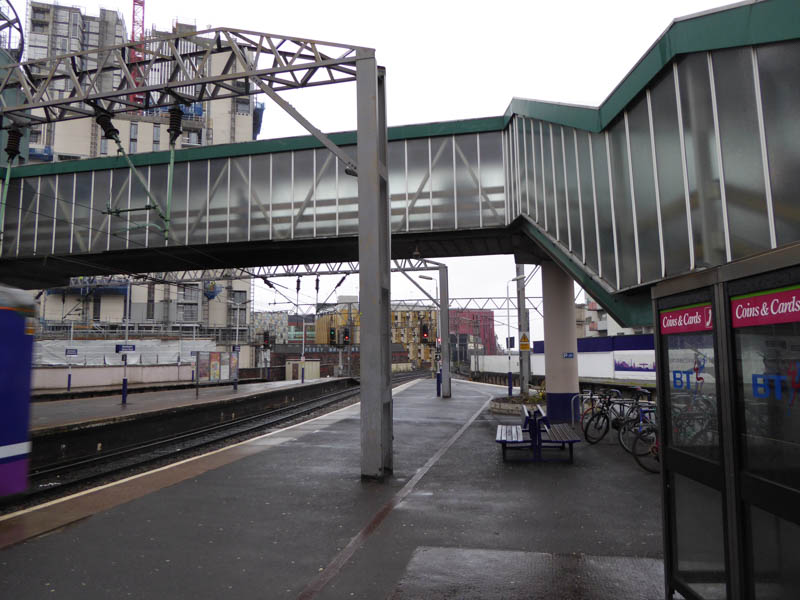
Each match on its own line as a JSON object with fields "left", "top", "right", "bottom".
{"left": 503, "top": 0, "right": 800, "bottom": 133}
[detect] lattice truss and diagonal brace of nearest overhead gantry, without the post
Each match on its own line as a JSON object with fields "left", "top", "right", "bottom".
{"left": 0, "top": 27, "right": 372, "bottom": 173}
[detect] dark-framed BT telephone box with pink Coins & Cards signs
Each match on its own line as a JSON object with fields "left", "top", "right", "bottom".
{"left": 653, "top": 247, "right": 800, "bottom": 600}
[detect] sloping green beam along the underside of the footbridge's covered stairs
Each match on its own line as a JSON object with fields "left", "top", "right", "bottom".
{"left": 512, "top": 216, "right": 654, "bottom": 327}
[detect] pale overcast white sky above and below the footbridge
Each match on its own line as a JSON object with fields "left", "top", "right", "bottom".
{"left": 17, "top": 0, "right": 729, "bottom": 341}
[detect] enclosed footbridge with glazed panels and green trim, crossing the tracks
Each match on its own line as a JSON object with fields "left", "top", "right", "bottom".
{"left": 0, "top": 2, "right": 800, "bottom": 332}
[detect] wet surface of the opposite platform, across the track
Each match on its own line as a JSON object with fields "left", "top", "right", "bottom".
{"left": 30, "top": 377, "right": 335, "bottom": 430}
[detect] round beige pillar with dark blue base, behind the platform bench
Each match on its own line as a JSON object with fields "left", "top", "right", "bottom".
{"left": 542, "top": 261, "right": 580, "bottom": 423}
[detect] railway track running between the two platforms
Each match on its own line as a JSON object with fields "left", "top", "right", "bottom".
{"left": 0, "top": 372, "right": 428, "bottom": 512}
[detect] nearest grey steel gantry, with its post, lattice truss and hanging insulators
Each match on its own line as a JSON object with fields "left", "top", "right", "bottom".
{"left": 0, "top": 28, "right": 392, "bottom": 478}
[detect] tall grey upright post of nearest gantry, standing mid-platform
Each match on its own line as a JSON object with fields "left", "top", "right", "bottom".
{"left": 358, "top": 55, "right": 392, "bottom": 479}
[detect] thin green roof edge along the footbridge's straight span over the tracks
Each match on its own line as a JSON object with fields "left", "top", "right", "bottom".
{"left": 11, "top": 116, "right": 505, "bottom": 178}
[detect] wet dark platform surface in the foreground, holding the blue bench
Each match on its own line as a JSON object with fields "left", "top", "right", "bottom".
{"left": 0, "top": 380, "right": 664, "bottom": 600}
